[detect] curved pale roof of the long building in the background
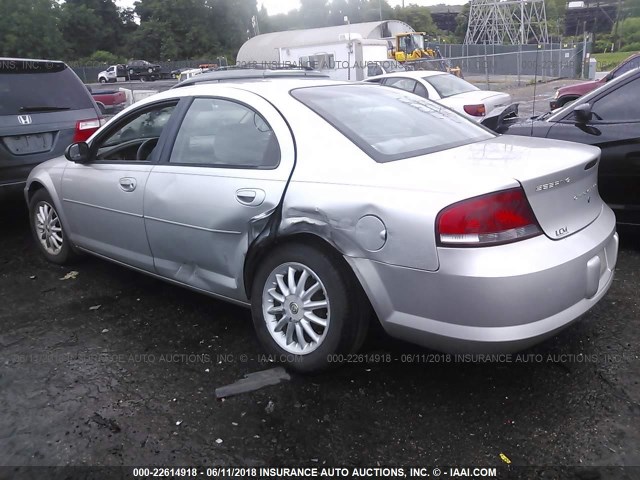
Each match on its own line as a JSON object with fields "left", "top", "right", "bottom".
{"left": 236, "top": 20, "right": 414, "bottom": 63}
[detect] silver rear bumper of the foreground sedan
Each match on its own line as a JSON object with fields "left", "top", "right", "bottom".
{"left": 347, "top": 206, "right": 618, "bottom": 353}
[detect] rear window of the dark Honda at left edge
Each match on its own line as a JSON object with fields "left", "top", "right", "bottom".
{"left": 0, "top": 59, "right": 93, "bottom": 115}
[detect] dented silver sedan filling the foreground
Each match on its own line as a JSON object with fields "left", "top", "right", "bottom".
{"left": 25, "top": 79, "right": 618, "bottom": 371}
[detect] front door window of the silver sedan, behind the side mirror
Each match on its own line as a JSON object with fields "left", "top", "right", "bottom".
{"left": 96, "top": 102, "right": 177, "bottom": 162}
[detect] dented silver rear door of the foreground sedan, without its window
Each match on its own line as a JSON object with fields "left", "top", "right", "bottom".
{"left": 144, "top": 91, "right": 295, "bottom": 301}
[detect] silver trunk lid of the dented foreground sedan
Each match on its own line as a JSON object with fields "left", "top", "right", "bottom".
{"left": 383, "top": 135, "right": 603, "bottom": 240}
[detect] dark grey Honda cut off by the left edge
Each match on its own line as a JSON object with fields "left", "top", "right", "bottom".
{"left": 0, "top": 57, "right": 103, "bottom": 192}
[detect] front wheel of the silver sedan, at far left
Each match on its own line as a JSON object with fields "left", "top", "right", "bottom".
{"left": 29, "top": 189, "right": 76, "bottom": 265}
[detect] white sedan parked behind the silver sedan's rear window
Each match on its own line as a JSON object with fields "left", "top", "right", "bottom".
{"left": 366, "top": 70, "right": 511, "bottom": 122}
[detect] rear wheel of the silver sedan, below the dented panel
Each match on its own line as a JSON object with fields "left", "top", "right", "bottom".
{"left": 251, "top": 244, "right": 370, "bottom": 372}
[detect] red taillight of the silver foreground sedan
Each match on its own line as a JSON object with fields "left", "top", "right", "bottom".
{"left": 436, "top": 188, "right": 542, "bottom": 247}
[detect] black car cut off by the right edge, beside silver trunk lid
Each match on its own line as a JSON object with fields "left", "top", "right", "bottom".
{"left": 498, "top": 69, "right": 640, "bottom": 225}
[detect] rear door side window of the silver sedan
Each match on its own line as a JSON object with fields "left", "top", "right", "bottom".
{"left": 169, "top": 98, "right": 280, "bottom": 168}
